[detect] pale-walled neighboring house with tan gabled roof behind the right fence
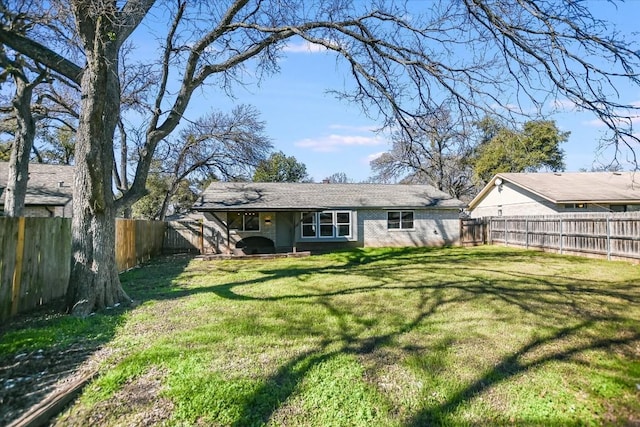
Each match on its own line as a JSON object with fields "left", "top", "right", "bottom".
{"left": 468, "top": 172, "right": 640, "bottom": 218}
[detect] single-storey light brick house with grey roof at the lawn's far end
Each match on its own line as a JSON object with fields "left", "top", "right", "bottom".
{"left": 194, "top": 182, "right": 464, "bottom": 253}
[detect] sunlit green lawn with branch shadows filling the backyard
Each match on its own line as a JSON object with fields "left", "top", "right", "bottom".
{"left": 0, "top": 247, "right": 640, "bottom": 426}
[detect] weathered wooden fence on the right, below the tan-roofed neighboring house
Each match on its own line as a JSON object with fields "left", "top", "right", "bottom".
{"left": 487, "top": 212, "right": 640, "bottom": 260}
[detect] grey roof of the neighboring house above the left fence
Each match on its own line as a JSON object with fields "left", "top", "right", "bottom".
{"left": 0, "top": 162, "right": 73, "bottom": 206}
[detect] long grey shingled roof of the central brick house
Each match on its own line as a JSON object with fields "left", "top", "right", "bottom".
{"left": 194, "top": 182, "right": 464, "bottom": 211}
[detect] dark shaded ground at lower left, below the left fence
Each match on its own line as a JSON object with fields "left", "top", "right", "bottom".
{"left": 0, "top": 303, "right": 123, "bottom": 425}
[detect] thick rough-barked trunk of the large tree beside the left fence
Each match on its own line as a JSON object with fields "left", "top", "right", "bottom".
{"left": 67, "top": 15, "right": 131, "bottom": 316}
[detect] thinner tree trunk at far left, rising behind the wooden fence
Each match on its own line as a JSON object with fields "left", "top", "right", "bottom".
{"left": 4, "top": 76, "right": 36, "bottom": 217}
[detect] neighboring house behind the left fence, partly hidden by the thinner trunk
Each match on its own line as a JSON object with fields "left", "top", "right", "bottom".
{"left": 0, "top": 162, "right": 73, "bottom": 217}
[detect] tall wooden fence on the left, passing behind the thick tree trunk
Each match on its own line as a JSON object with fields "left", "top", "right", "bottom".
{"left": 0, "top": 217, "right": 166, "bottom": 321}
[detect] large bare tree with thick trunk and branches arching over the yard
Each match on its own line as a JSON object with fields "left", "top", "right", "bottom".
{"left": 0, "top": 0, "right": 640, "bottom": 315}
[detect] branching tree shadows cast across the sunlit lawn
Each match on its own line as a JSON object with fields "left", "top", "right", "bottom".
{"left": 117, "top": 248, "right": 640, "bottom": 426}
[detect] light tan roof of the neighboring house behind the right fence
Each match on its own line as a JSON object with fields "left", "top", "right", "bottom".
{"left": 469, "top": 172, "right": 640, "bottom": 209}
